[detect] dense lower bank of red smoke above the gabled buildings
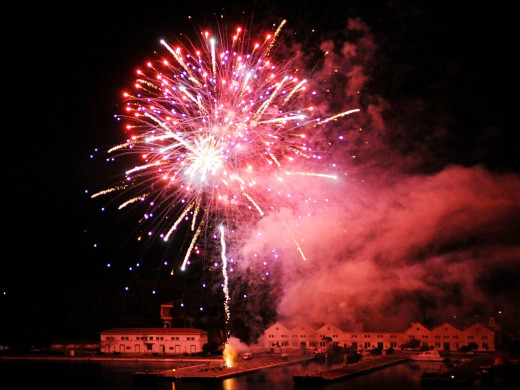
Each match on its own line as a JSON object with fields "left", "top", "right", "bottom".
{"left": 243, "top": 166, "right": 520, "bottom": 329}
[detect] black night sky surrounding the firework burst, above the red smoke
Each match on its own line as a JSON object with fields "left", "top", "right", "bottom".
{"left": 0, "top": 0, "right": 520, "bottom": 343}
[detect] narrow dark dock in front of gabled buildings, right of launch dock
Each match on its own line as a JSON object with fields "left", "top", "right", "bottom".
{"left": 293, "top": 353, "right": 409, "bottom": 385}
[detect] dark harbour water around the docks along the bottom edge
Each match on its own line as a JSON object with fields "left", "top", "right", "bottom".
{"left": 0, "top": 360, "right": 514, "bottom": 390}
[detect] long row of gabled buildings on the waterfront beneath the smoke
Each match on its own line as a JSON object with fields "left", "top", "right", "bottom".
{"left": 264, "top": 321, "right": 495, "bottom": 351}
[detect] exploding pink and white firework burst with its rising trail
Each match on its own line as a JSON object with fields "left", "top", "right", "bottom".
{"left": 92, "top": 21, "right": 358, "bottom": 338}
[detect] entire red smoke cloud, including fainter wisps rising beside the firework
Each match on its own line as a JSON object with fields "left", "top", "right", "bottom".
{"left": 230, "top": 19, "right": 520, "bottom": 336}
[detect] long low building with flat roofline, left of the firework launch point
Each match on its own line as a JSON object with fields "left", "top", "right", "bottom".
{"left": 100, "top": 327, "right": 208, "bottom": 354}
